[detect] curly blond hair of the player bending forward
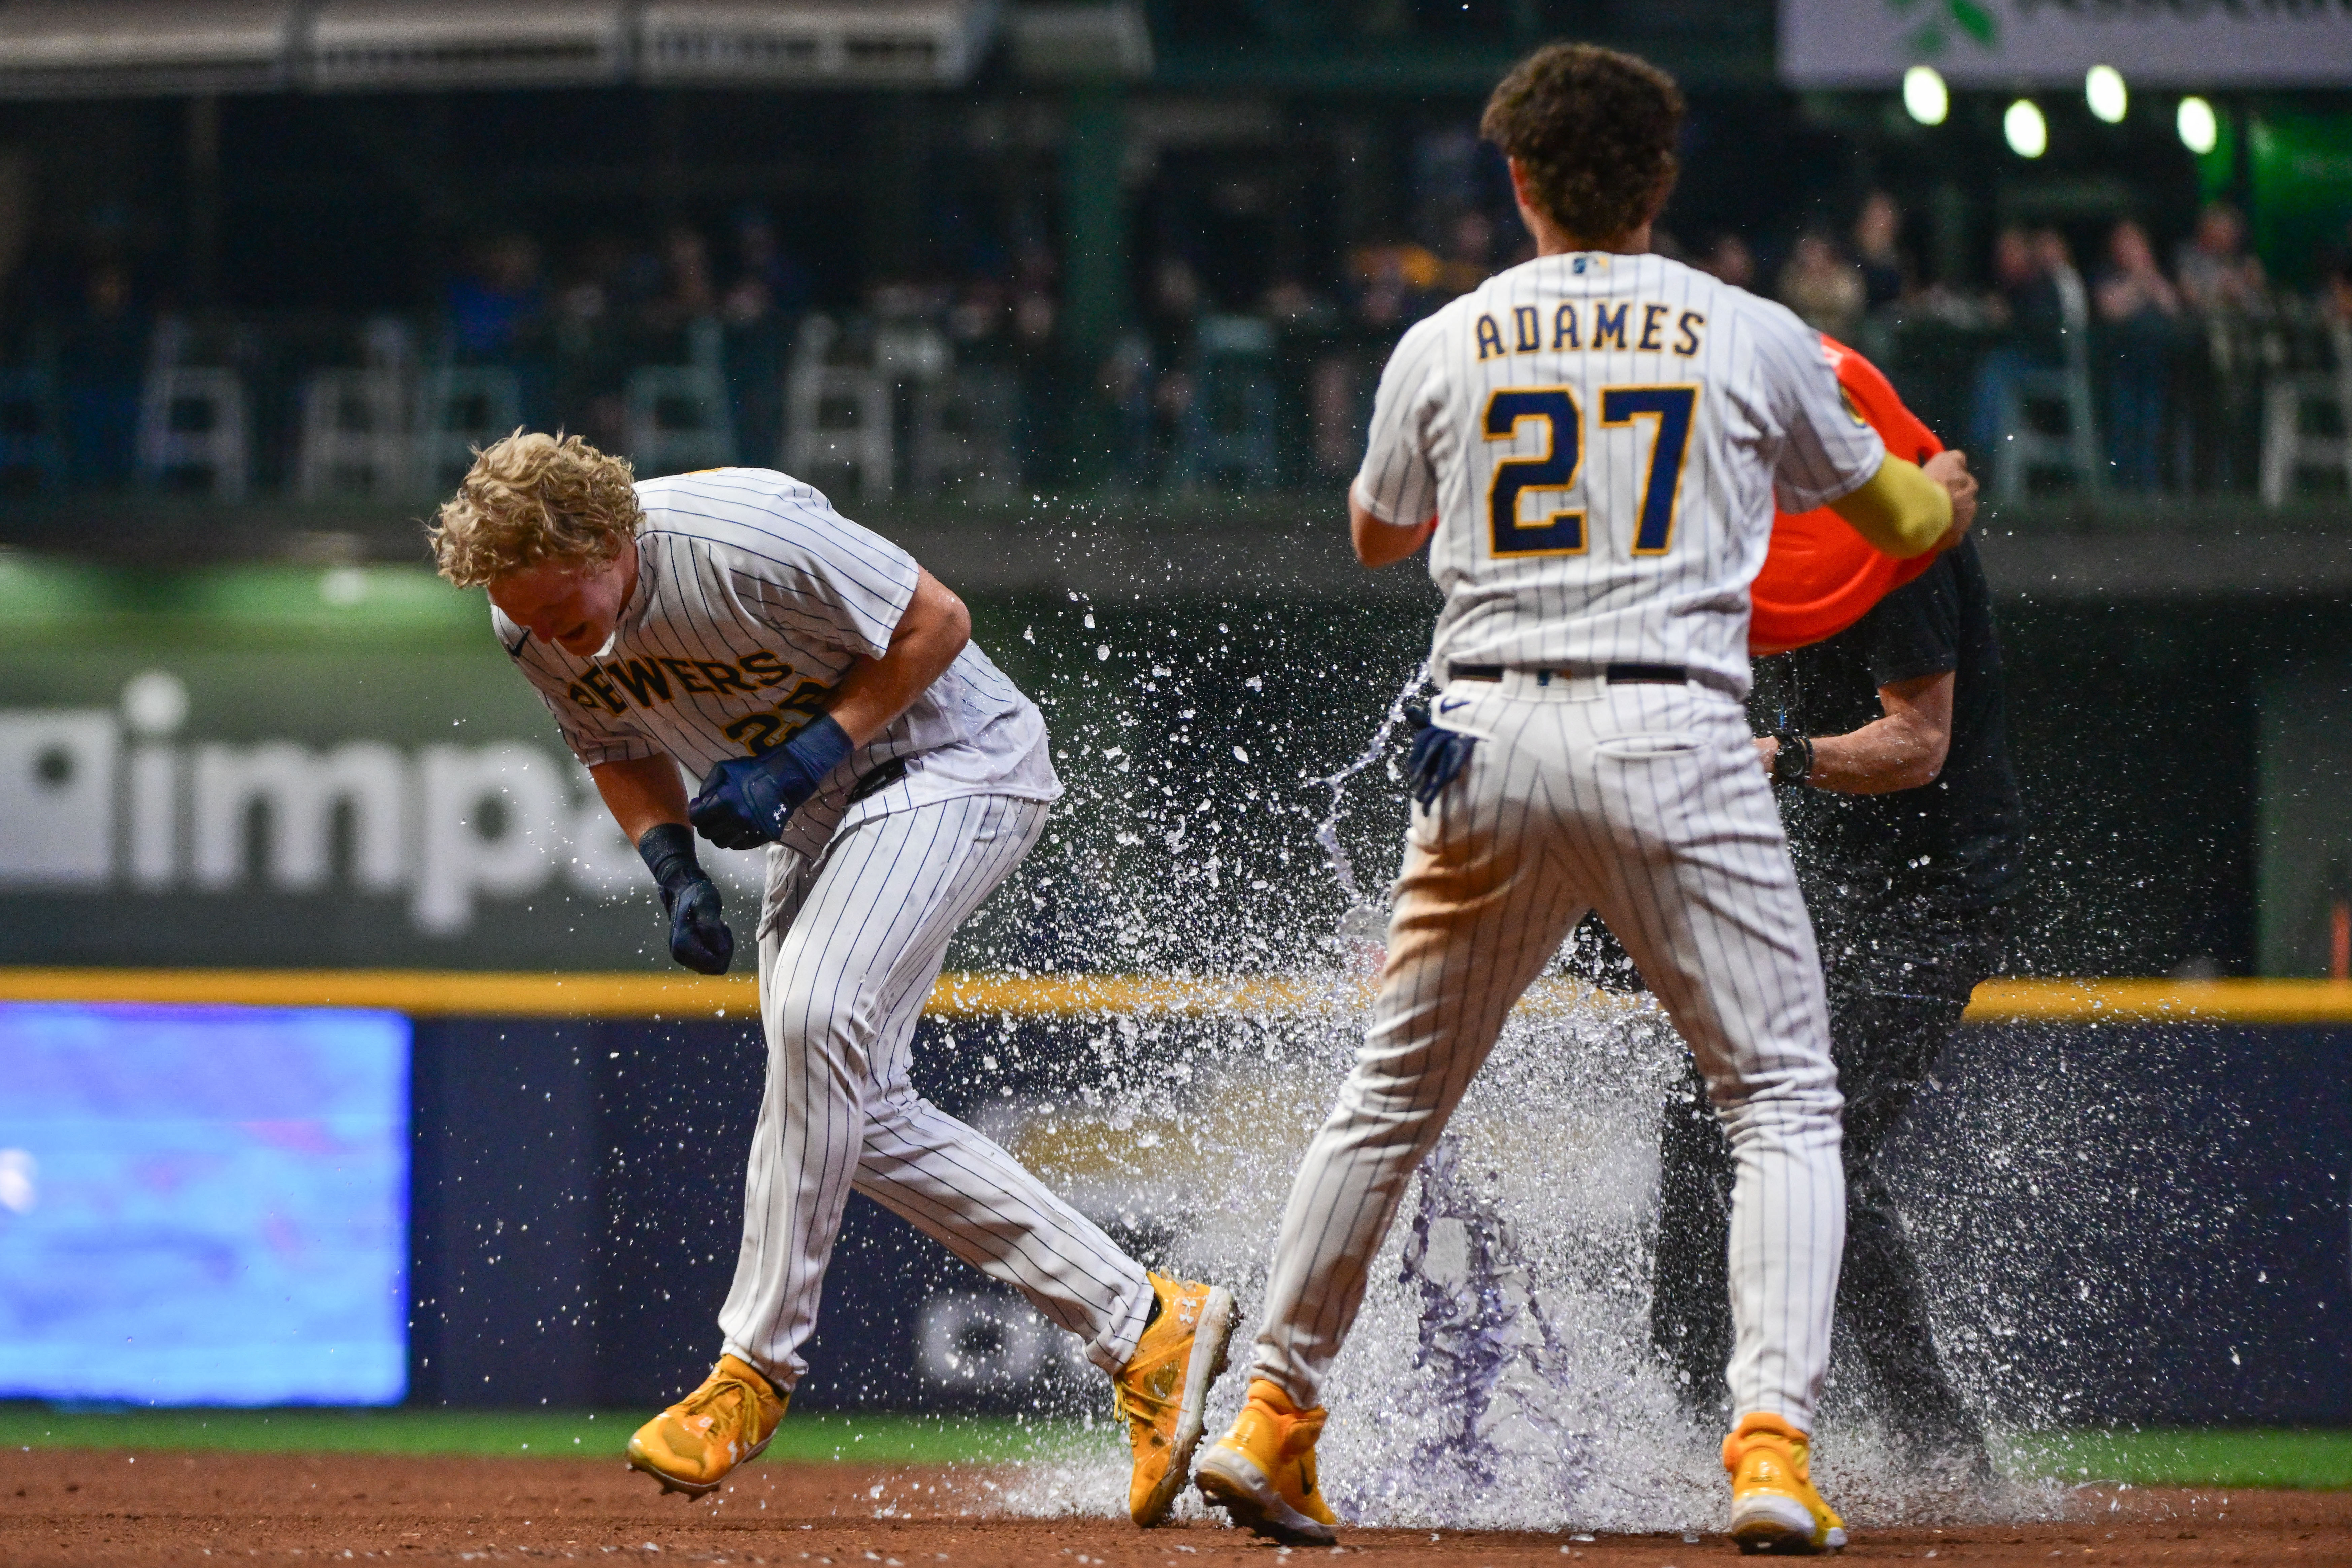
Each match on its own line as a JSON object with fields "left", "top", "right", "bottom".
{"left": 426, "top": 428, "right": 645, "bottom": 588}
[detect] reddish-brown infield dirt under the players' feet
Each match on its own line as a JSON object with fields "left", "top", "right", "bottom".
{"left": 0, "top": 1448, "right": 2352, "bottom": 1568}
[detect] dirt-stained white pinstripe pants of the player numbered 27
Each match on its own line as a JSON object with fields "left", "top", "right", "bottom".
{"left": 1256, "top": 672, "right": 1846, "bottom": 1432}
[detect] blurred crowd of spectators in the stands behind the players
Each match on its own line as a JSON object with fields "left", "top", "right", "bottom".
{"left": 0, "top": 193, "right": 2352, "bottom": 510}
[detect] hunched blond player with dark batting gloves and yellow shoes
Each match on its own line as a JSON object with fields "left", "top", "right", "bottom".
{"left": 433, "top": 430, "right": 1233, "bottom": 1526}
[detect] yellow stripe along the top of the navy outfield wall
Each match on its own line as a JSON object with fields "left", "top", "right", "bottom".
{"left": 0, "top": 969, "right": 2352, "bottom": 1025}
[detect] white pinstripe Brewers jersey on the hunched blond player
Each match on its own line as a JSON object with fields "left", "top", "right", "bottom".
{"left": 492, "top": 468, "right": 1061, "bottom": 856}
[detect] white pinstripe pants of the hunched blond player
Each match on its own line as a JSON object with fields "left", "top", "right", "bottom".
{"left": 720, "top": 794, "right": 1152, "bottom": 1389}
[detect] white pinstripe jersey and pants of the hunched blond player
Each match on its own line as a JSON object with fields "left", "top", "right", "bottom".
{"left": 496, "top": 468, "right": 1152, "bottom": 1420}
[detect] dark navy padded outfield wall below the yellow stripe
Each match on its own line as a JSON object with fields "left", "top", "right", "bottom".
{"left": 412, "top": 1018, "right": 2352, "bottom": 1425}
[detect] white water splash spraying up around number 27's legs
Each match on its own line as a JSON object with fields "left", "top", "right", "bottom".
{"left": 959, "top": 602, "right": 2107, "bottom": 1530}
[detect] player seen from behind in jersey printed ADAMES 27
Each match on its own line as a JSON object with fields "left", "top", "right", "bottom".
{"left": 1200, "top": 45, "right": 1976, "bottom": 1551}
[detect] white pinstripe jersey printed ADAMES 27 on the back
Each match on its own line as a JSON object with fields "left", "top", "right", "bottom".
{"left": 1355, "top": 252, "right": 1886, "bottom": 691}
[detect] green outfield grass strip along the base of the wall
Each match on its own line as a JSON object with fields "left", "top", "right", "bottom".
{"left": 0, "top": 1403, "right": 2352, "bottom": 1491}
